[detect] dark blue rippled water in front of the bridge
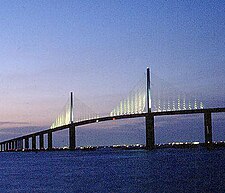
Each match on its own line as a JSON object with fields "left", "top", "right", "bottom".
{"left": 0, "top": 148, "right": 225, "bottom": 193}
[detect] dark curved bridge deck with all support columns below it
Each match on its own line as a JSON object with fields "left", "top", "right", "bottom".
{"left": 0, "top": 108, "right": 225, "bottom": 151}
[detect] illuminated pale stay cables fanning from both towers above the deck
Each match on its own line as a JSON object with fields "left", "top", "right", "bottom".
{"left": 51, "top": 69, "right": 204, "bottom": 129}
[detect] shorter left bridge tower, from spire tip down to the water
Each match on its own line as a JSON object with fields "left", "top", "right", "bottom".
{"left": 69, "top": 92, "right": 76, "bottom": 150}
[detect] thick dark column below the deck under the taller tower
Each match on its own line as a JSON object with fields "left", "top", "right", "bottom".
{"left": 145, "top": 114, "right": 155, "bottom": 149}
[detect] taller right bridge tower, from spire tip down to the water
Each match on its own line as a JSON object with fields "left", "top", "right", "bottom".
{"left": 145, "top": 68, "right": 155, "bottom": 149}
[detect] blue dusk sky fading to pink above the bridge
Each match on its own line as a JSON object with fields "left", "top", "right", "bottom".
{"left": 0, "top": 0, "right": 225, "bottom": 145}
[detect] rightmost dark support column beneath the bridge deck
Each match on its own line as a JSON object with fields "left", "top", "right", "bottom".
{"left": 204, "top": 112, "right": 212, "bottom": 145}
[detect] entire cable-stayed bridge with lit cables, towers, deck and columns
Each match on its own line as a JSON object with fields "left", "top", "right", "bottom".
{"left": 0, "top": 68, "right": 225, "bottom": 151}
